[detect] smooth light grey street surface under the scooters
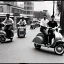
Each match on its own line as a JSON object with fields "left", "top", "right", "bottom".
{"left": 0, "top": 27, "right": 64, "bottom": 63}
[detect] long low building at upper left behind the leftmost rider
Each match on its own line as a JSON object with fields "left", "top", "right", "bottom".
{"left": 0, "top": 2, "right": 24, "bottom": 28}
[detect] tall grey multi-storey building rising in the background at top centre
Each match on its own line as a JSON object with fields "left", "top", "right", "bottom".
{"left": 24, "top": 1, "right": 34, "bottom": 15}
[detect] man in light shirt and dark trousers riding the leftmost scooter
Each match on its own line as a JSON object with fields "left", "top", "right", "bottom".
{"left": 2, "top": 14, "right": 14, "bottom": 40}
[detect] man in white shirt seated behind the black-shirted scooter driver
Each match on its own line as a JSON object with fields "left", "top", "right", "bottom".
{"left": 40, "top": 15, "right": 49, "bottom": 44}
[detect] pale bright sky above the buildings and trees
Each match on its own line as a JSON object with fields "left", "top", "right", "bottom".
{"left": 18, "top": 1, "right": 56, "bottom": 15}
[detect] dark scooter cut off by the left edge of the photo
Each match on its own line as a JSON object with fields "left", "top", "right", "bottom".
{"left": 0, "top": 24, "right": 14, "bottom": 43}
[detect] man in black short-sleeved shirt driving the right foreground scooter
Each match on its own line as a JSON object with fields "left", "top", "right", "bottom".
{"left": 48, "top": 15, "right": 58, "bottom": 44}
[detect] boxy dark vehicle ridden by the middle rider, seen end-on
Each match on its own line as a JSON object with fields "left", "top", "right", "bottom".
{"left": 17, "top": 24, "right": 26, "bottom": 38}
